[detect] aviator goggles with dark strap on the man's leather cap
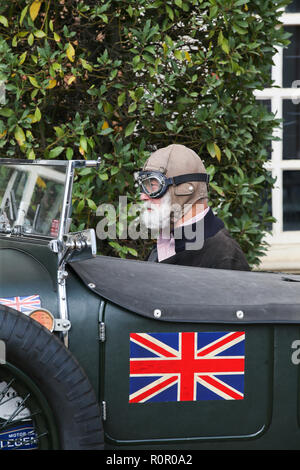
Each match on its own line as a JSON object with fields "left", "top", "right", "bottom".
{"left": 134, "top": 171, "right": 209, "bottom": 199}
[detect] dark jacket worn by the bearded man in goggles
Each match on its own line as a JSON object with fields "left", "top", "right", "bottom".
{"left": 147, "top": 210, "right": 250, "bottom": 271}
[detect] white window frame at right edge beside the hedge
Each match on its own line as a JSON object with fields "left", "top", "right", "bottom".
{"left": 254, "top": 13, "right": 300, "bottom": 248}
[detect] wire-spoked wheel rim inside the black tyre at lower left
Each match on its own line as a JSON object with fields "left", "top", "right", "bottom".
{"left": 0, "top": 362, "right": 59, "bottom": 450}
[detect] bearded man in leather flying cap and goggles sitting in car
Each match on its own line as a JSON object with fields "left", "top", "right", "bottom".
{"left": 135, "top": 144, "right": 250, "bottom": 271}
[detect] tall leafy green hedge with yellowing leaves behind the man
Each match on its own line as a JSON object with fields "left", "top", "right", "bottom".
{"left": 0, "top": 0, "right": 289, "bottom": 265}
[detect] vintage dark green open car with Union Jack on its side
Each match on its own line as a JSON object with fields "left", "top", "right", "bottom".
{"left": 0, "top": 159, "right": 300, "bottom": 451}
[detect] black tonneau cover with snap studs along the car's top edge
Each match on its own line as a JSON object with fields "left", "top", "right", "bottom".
{"left": 70, "top": 256, "right": 300, "bottom": 323}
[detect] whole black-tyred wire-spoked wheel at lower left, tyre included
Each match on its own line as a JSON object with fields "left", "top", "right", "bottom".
{"left": 0, "top": 305, "right": 103, "bottom": 450}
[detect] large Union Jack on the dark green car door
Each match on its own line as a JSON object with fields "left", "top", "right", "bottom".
{"left": 129, "top": 331, "right": 245, "bottom": 403}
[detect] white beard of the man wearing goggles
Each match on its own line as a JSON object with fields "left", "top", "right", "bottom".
{"left": 140, "top": 192, "right": 171, "bottom": 231}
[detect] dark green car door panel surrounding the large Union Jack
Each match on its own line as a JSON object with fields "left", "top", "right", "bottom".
{"left": 104, "top": 304, "right": 273, "bottom": 444}
